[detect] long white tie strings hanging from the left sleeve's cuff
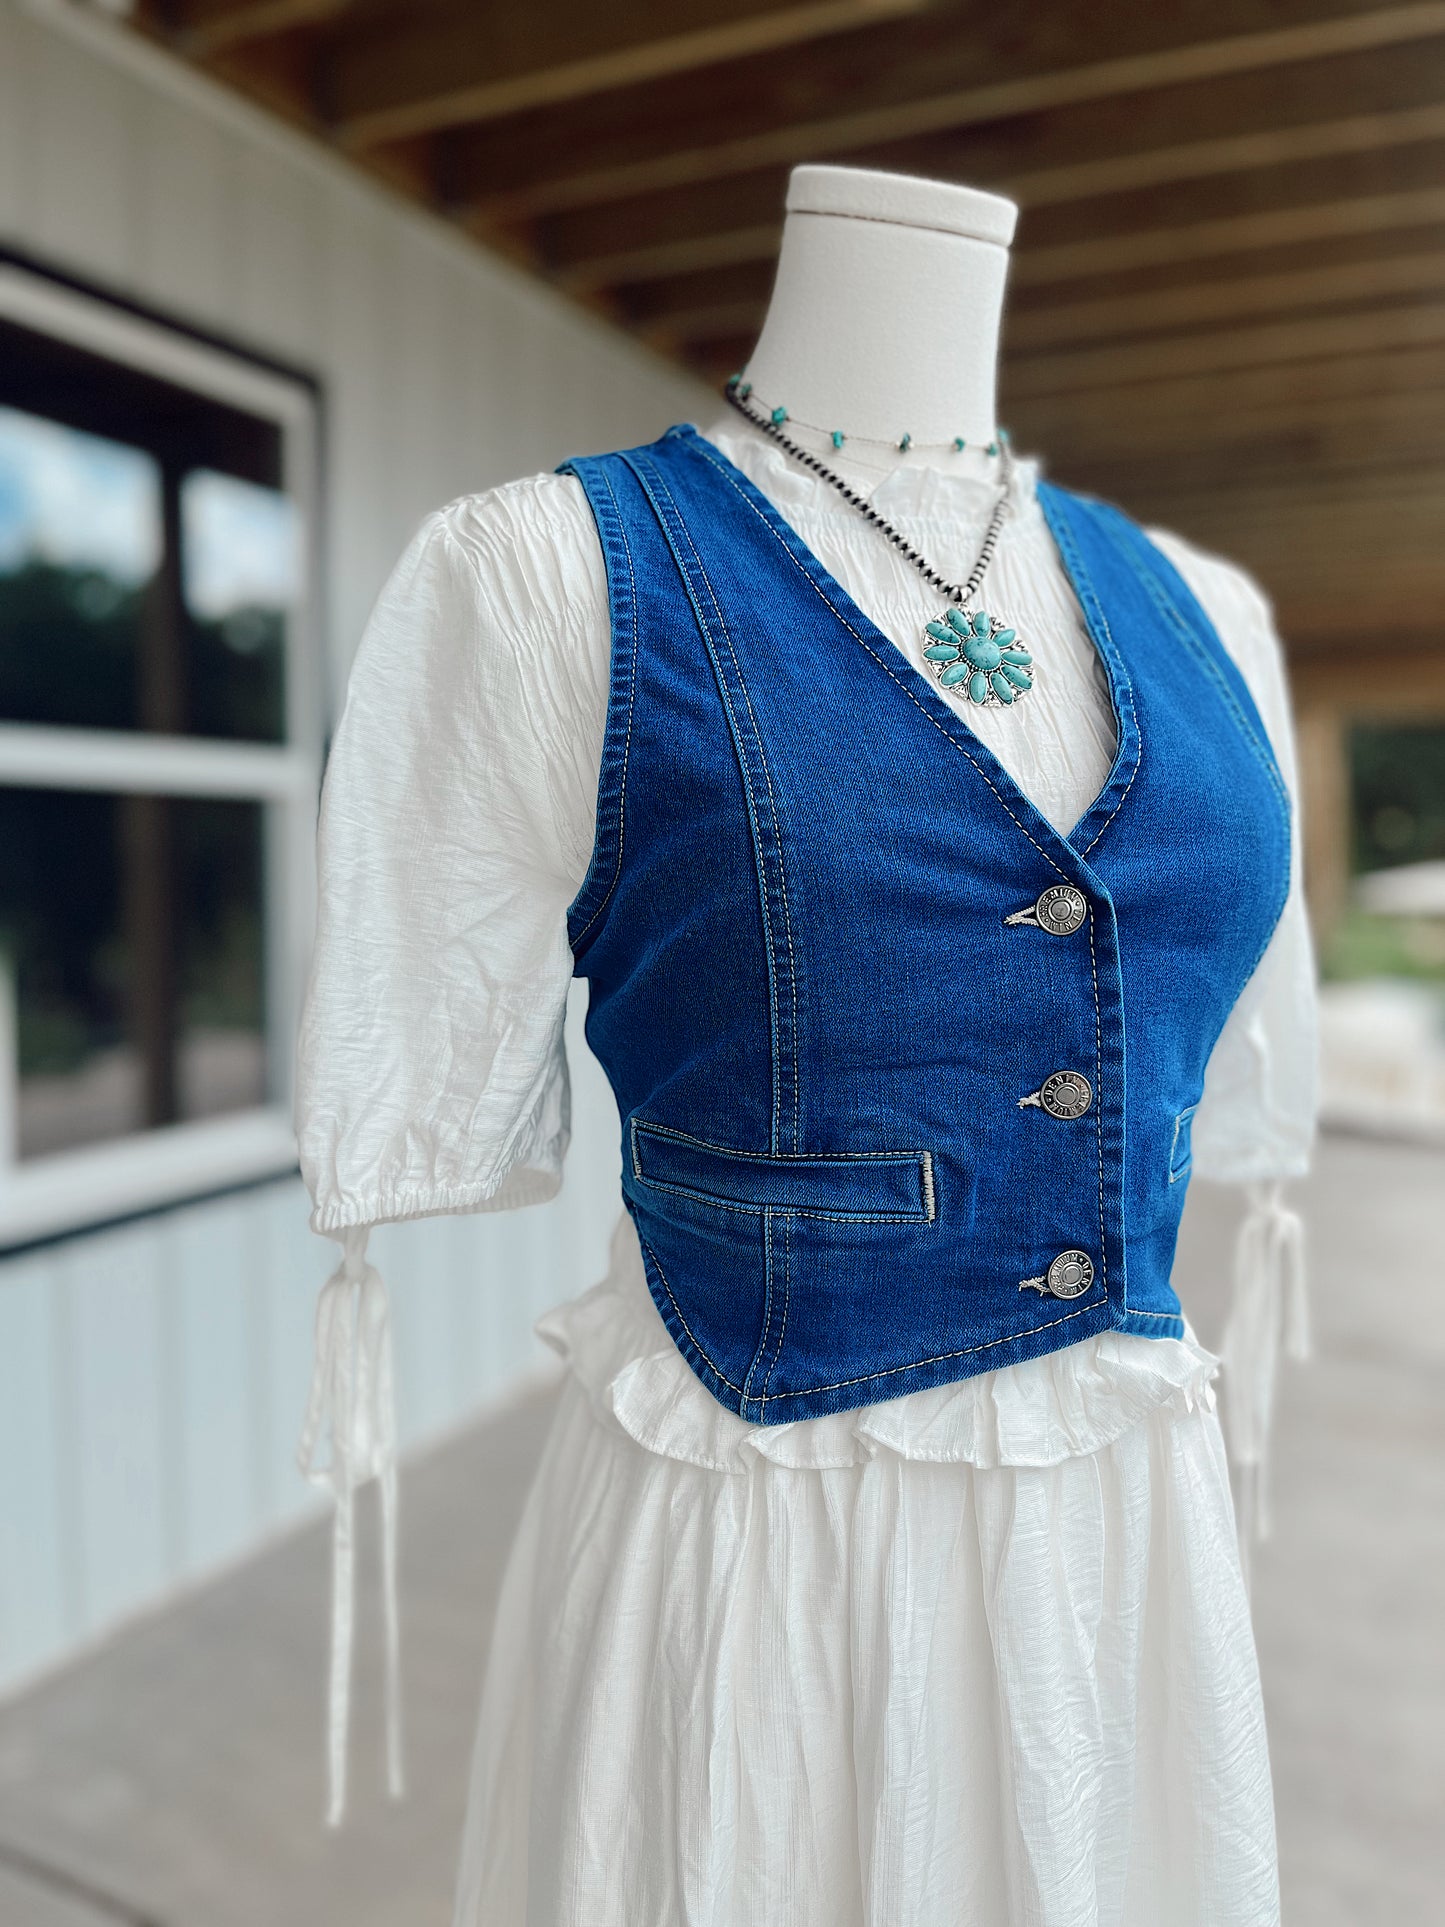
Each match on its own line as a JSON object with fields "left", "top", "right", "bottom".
{"left": 297, "top": 1226, "right": 403, "bottom": 1827}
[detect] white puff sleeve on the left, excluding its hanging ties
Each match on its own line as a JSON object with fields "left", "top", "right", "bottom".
{"left": 295, "top": 489, "right": 601, "bottom": 1233}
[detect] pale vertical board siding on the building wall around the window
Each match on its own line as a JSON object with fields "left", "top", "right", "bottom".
{"left": 0, "top": 0, "right": 707, "bottom": 1688}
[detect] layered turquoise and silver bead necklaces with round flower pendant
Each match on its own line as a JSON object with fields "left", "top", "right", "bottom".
{"left": 723, "top": 374, "right": 1033, "bottom": 709}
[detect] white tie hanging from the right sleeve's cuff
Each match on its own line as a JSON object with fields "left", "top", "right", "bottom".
{"left": 1222, "top": 1179, "right": 1310, "bottom": 1582}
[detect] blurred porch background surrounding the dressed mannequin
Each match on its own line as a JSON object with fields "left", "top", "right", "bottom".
{"left": 0, "top": 0, "right": 1445, "bottom": 1927}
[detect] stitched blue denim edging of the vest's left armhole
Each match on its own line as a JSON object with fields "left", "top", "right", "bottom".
{"left": 557, "top": 455, "right": 638, "bottom": 962}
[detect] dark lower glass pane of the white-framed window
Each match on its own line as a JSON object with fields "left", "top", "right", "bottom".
{"left": 0, "top": 788, "right": 268, "bottom": 1158}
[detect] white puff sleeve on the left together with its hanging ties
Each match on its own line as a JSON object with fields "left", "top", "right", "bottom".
{"left": 295, "top": 476, "right": 605, "bottom": 1823}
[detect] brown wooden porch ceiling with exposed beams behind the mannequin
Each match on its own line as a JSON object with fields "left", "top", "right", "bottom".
{"left": 133, "top": 0, "right": 1445, "bottom": 709}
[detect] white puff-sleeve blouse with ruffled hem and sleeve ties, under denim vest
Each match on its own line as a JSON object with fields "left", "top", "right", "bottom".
{"left": 297, "top": 418, "right": 1316, "bottom": 1819}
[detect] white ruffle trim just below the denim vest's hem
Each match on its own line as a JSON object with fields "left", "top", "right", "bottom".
{"left": 534, "top": 1214, "right": 1220, "bottom": 1472}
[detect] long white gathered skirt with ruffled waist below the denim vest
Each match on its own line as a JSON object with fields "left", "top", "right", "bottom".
{"left": 455, "top": 1218, "right": 1279, "bottom": 1927}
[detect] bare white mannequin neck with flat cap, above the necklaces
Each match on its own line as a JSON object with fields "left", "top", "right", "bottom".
{"left": 744, "top": 168, "right": 1017, "bottom": 476}
